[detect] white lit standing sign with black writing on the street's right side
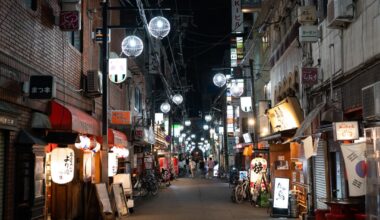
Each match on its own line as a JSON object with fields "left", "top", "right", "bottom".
{"left": 272, "top": 178, "right": 289, "bottom": 216}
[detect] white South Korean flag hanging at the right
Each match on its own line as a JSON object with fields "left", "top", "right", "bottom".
{"left": 340, "top": 143, "right": 367, "bottom": 196}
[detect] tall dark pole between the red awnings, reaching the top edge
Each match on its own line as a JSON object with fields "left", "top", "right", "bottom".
{"left": 100, "top": 0, "right": 109, "bottom": 185}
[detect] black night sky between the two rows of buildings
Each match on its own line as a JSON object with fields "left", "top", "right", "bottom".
{"left": 163, "top": 0, "right": 231, "bottom": 117}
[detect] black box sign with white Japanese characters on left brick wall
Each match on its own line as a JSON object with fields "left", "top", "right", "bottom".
{"left": 29, "top": 75, "right": 56, "bottom": 99}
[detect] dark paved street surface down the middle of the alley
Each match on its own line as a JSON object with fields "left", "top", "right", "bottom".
{"left": 128, "top": 178, "right": 271, "bottom": 220}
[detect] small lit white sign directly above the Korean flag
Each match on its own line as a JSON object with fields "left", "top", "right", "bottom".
{"left": 333, "top": 121, "right": 359, "bottom": 141}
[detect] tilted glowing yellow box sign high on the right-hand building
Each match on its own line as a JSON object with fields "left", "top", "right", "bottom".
{"left": 268, "top": 97, "right": 303, "bottom": 132}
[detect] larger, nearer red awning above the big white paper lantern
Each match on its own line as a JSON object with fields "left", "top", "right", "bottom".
{"left": 49, "top": 101, "right": 100, "bottom": 136}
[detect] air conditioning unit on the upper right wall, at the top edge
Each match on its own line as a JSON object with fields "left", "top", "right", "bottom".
{"left": 327, "top": 0, "right": 355, "bottom": 29}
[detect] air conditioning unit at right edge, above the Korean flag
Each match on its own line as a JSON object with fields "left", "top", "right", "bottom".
{"left": 362, "top": 81, "right": 380, "bottom": 120}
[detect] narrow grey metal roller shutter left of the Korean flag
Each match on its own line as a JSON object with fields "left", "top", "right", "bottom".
{"left": 313, "top": 139, "right": 327, "bottom": 209}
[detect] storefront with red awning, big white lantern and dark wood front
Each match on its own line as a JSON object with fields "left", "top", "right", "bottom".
{"left": 46, "top": 101, "right": 101, "bottom": 219}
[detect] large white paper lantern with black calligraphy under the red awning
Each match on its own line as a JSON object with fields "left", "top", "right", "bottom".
{"left": 51, "top": 147, "right": 75, "bottom": 184}
